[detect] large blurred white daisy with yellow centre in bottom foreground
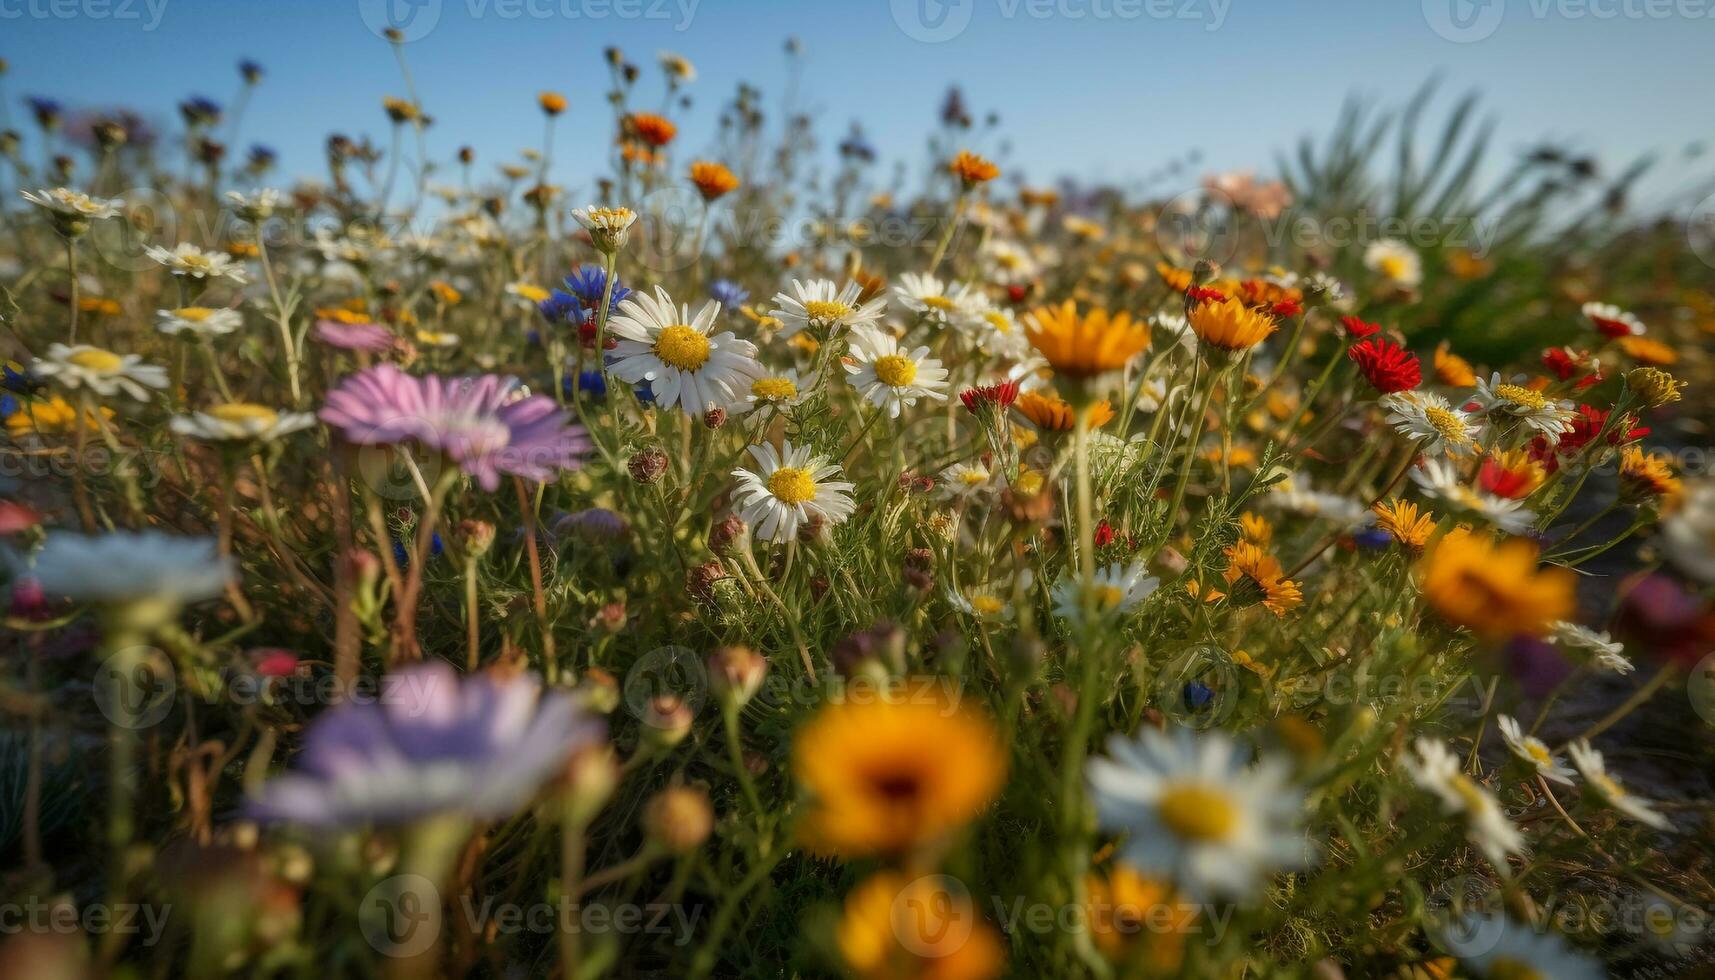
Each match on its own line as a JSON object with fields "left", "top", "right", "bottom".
{"left": 1086, "top": 728, "right": 1309, "bottom": 899}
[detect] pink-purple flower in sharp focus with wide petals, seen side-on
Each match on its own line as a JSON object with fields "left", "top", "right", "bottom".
{"left": 321, "top": 364, "right": 592, "bottom": 491}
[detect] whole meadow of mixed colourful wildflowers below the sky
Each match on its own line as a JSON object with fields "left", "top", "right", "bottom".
{"left": 0, "top": 13, "right": 1715, "bottom": 980}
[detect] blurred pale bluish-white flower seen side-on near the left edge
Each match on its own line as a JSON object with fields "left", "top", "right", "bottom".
{"left": 33, "top": 530, "right": 235, "bottom": 606}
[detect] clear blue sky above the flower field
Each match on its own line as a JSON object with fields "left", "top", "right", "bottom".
{"left": 0, "top": 0, "right": 1715, "bottom": 209}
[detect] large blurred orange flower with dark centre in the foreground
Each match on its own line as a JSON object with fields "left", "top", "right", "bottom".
{"left": 792, "top": 690, "right": 1007, "bottom": 858}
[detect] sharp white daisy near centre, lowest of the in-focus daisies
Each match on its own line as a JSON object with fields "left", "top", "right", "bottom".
{"left": 732, "top": 441, "right": 856, "bottom": 541}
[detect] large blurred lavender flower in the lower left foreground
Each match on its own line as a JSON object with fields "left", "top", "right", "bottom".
{"left": 245, "top": 661, "right": 604, "bottom": 827}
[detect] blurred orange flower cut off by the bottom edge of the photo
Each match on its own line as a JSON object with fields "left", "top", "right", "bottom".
{"left": 833, "top": 872, "right": 1007, "bottom": 980}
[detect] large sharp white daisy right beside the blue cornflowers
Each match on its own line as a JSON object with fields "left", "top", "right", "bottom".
{"left": 607, "top": 287, "right": 763, "bottom": 415}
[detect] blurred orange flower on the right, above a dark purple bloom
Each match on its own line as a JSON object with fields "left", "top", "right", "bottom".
{"left": 1418, "top": 527, "right": 1576, "bottom": 640}
